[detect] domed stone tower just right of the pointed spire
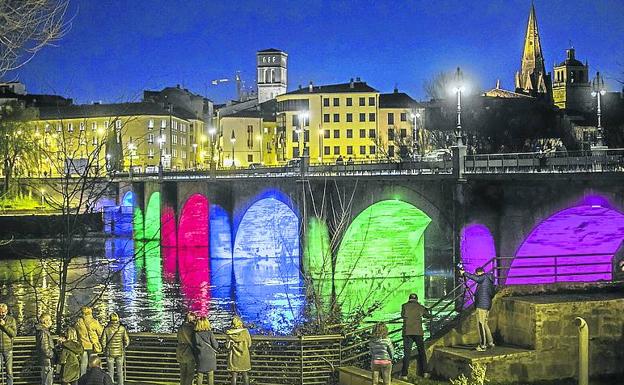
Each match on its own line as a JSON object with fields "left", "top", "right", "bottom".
{"left": 553, "top": 48, "right": 592, "bottom": 112}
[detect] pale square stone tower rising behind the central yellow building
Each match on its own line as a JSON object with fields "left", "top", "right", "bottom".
{"left": 257, "top": 48, "right": 288, "bottom": 103}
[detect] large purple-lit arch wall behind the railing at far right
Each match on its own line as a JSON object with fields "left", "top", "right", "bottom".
{"left": 506, "top": 201, "right": 624, "bottom": 285}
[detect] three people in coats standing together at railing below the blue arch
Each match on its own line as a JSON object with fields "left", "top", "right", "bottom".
{"left": 176, "top": 313, "right": 251, "bottom": 385}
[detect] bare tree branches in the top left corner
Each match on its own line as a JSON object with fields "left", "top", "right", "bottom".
{"left": 0, "top": 0, "right": 71, "bottom": 77}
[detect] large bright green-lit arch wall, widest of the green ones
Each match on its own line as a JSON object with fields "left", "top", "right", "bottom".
{"left": 336, "top": 200, "right": 431, "bottom": 319}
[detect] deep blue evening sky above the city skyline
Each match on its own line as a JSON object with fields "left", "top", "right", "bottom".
{"left": 6, "top": 0, "right": 624, "bottom": 103}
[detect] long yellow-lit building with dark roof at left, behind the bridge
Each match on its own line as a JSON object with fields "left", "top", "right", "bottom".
{"left": 32, "top": 102, "right": 209, "bottom": 175}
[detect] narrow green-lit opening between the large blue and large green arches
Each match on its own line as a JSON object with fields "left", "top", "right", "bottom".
{"left": 303, "top": 217, "right": 331, "bottom": 279}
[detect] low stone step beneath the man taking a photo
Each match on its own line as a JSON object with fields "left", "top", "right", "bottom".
{"left": 429, "top": 345, "right": 536, "bottom": 381}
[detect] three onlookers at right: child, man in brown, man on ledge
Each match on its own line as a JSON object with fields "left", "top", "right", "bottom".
{"left": 369, "top": 267, "right": 495, "bottom": 385}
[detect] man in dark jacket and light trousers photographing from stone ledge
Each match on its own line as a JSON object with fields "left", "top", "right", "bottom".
{"left": 459, "top": 267, "right": 494, "bottom": 352}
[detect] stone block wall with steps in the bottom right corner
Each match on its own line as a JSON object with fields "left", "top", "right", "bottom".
{"left": 426, "top": 287, "right": 624, "bottom": 382}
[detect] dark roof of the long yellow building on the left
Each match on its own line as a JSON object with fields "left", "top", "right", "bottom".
{"left": 39, "top": 102, "right": 195, "bottom": 120}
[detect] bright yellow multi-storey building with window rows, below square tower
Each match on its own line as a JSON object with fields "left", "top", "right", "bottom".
{"left": 277, "top": 78, "right": 424, "bottom": 163}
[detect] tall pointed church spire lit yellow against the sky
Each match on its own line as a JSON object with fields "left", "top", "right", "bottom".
{"left": 516, "top": 4, "right": 550, "bottom": 99}
